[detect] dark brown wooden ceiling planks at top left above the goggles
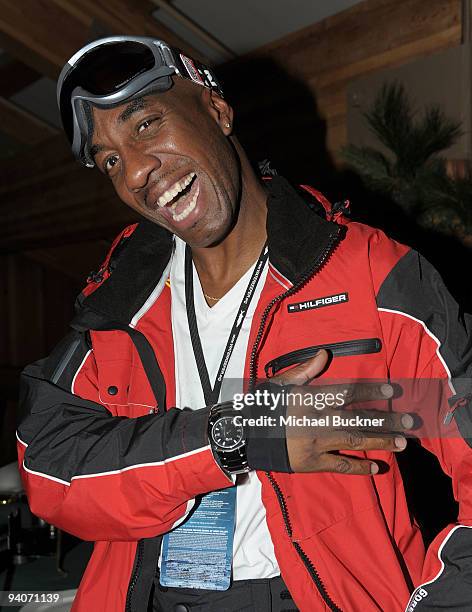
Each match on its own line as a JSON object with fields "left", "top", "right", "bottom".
{"left": 0, "top": 0, "right": 208, "bottom": 79}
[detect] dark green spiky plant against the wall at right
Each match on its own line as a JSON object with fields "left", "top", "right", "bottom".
{"left": 341, "top": 83, "right": 472, "bottom": 244}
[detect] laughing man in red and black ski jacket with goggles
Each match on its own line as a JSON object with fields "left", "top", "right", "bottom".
{"left": 18, "top": 37, "right": 472, "bottom": 612}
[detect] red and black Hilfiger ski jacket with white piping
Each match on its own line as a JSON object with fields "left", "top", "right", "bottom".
{"left": 18, "top": 178, "right": 472, "bottom": 612}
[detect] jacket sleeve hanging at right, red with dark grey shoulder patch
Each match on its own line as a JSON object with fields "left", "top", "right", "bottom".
{"left": 371, "top": 237, "right": 472, "bottom": 612}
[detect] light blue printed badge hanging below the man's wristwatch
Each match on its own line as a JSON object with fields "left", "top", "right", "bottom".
{"left": 160, "top": 487, "right": 236, "bottom": 591}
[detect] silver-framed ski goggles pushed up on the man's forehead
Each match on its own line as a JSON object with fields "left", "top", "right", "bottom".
{"left": 57, "top": 36, "right": 223, "bottom": 168}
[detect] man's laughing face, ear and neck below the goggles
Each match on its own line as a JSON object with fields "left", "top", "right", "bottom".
{"left": 86, "top": 73, "right": 267, "bottom": 302}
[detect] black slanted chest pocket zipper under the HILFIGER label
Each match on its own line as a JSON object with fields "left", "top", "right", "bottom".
{"left": 264, "top": 338, "right": 382, "bottom": 376}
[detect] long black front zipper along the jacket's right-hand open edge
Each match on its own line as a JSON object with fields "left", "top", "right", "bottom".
{"left": 249, "top": 227, "right": 342, "bottom": 612}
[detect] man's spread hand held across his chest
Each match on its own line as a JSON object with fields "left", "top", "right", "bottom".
{"left": 271, "top": 350, "right": 414, "bottom": 474}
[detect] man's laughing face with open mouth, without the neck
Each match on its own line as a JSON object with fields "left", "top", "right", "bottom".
{"left": 91, "top": 78, "right": 241, "bottom": 247}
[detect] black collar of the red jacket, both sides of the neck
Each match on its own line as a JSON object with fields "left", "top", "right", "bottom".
{"left": 72, "top": 176, "right": 339, "bottom": 329}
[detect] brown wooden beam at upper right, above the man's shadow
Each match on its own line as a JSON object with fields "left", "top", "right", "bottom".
{"left": 225, "top": 0, "right": 461, "bottom": 88}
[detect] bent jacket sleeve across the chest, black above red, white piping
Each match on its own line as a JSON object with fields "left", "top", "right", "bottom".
{"left": 17, "top": 332, "right": 233, "bottom": 540}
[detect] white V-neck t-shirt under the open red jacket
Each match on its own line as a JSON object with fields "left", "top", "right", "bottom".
{"left": 170, "top": 237, "right": 280, "bottom": 580}
